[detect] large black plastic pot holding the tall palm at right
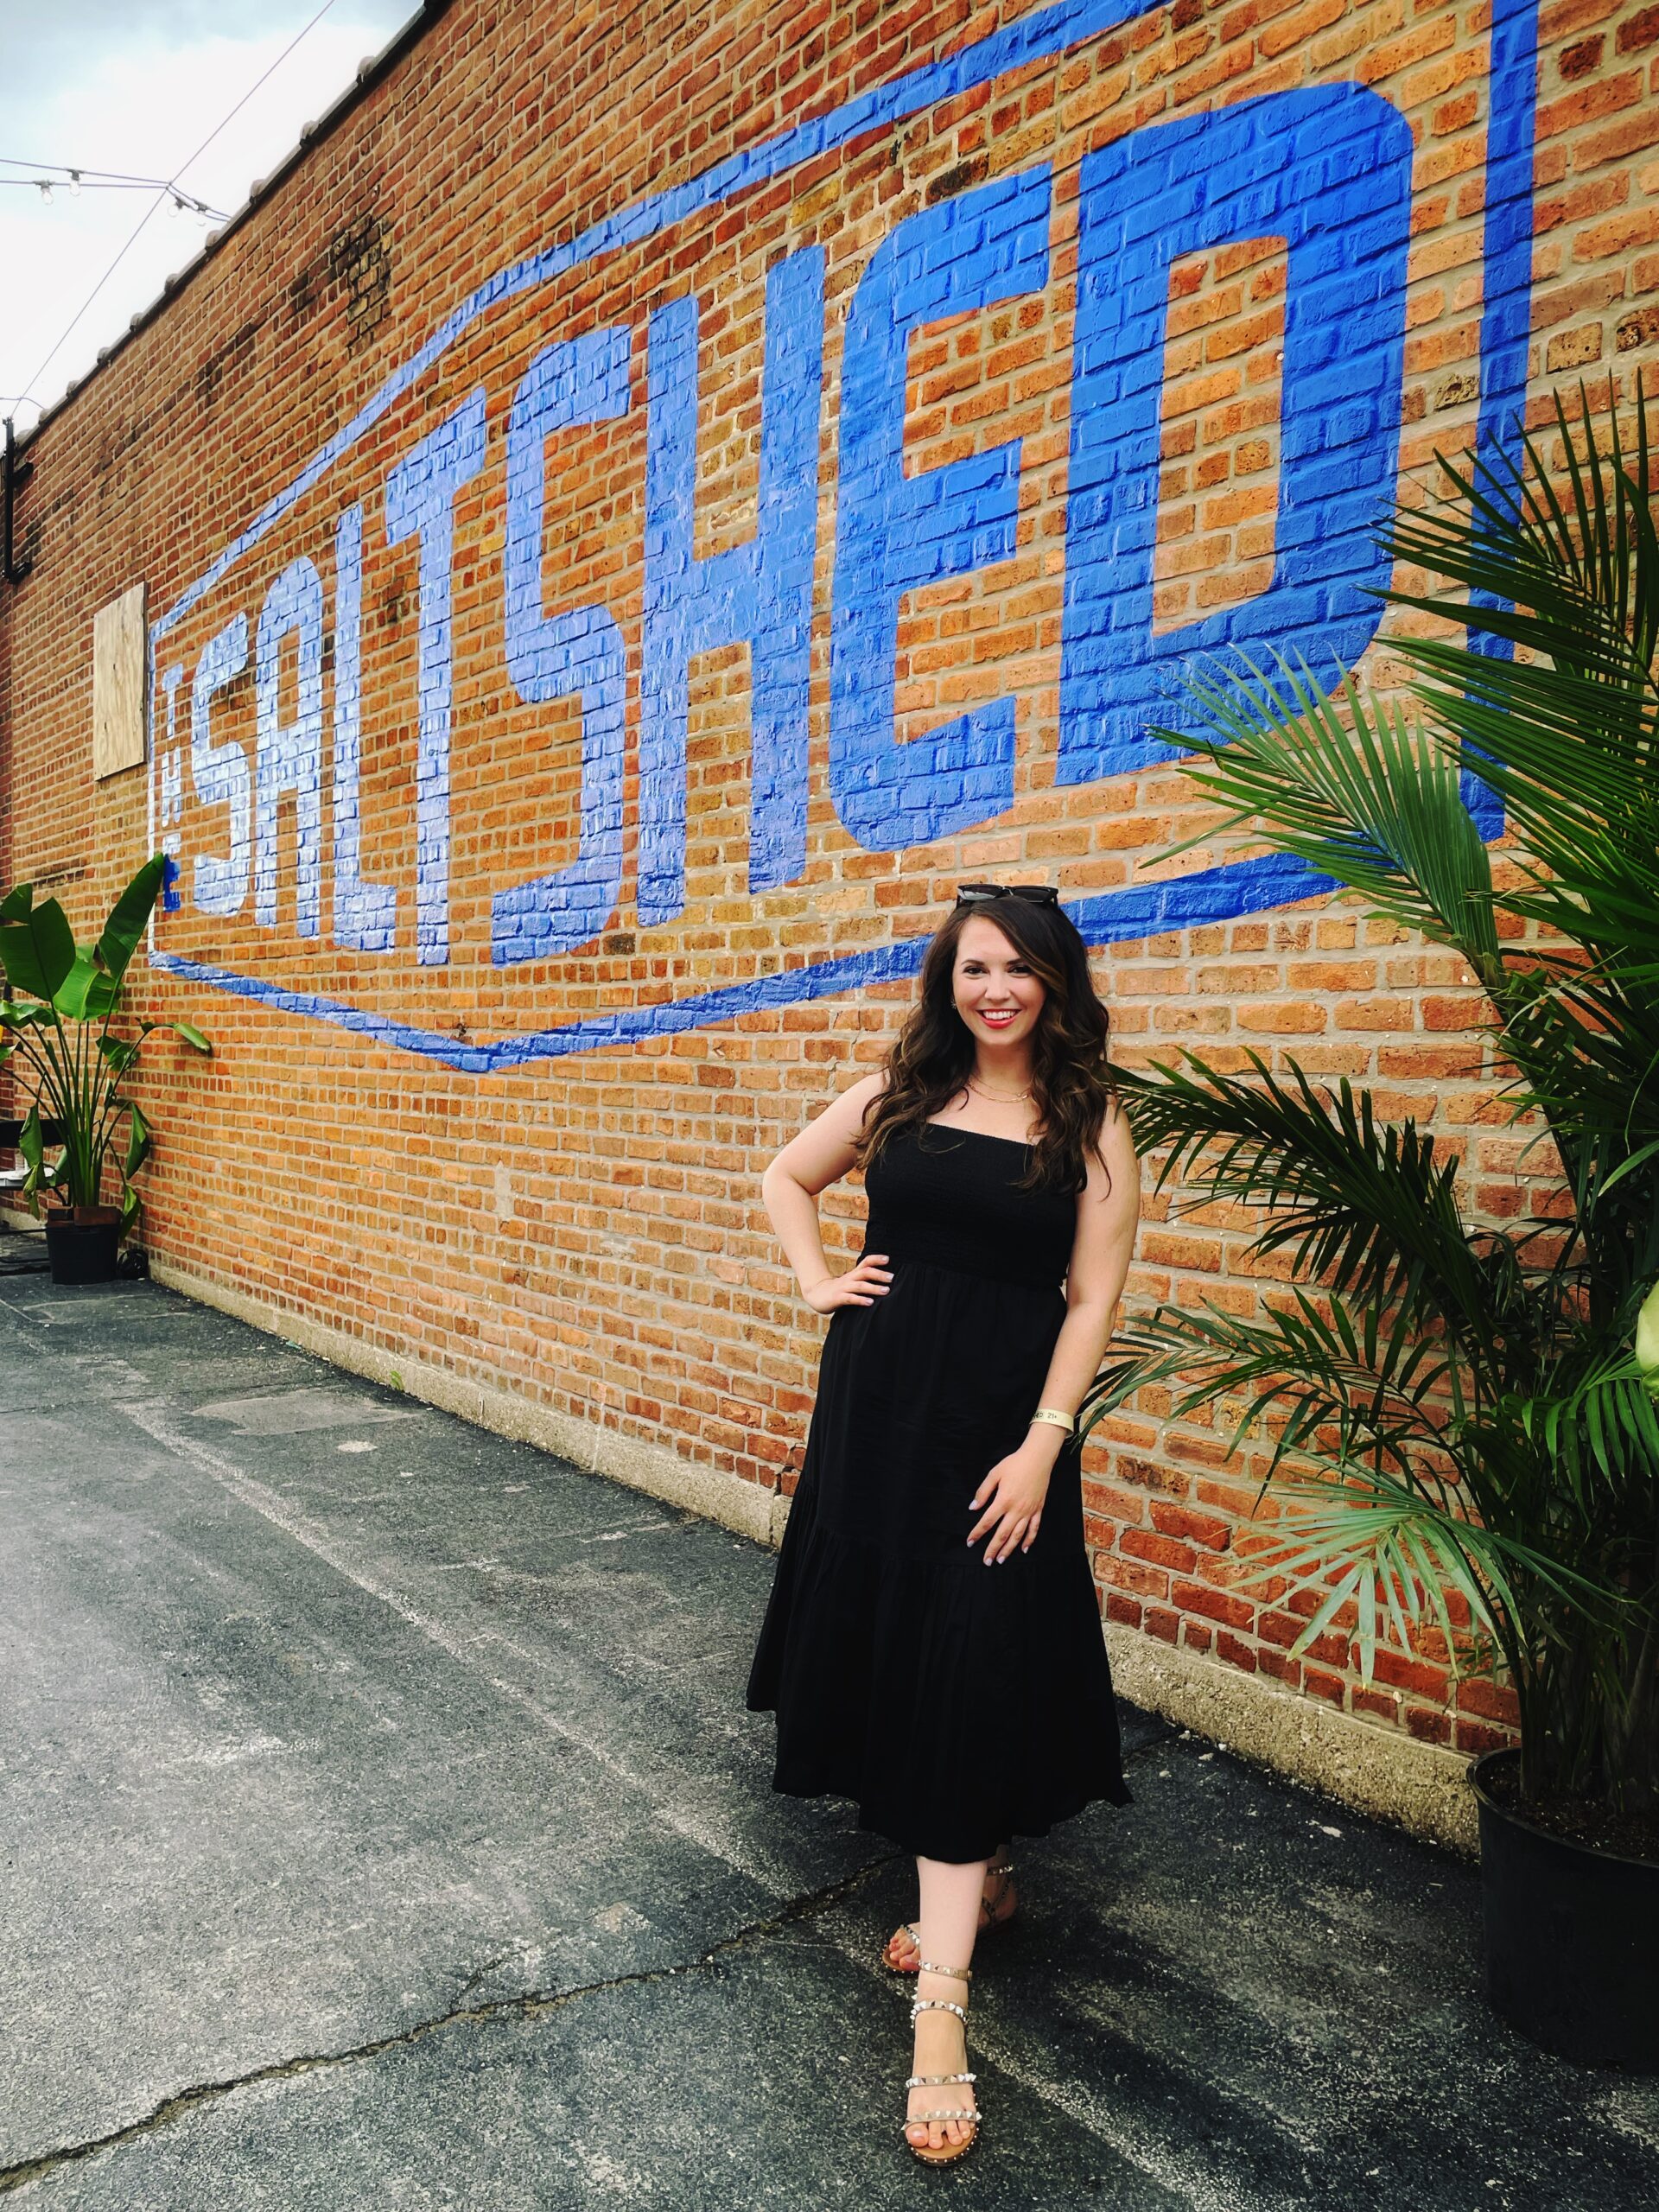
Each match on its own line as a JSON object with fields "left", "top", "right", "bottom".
{"left": 1469, "top": 1752, "right": 1659, "bottom": 2075}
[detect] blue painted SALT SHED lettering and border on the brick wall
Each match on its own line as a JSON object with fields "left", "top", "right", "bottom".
{"left": 150, "top": 0, "right": 1535, "bottom": 1073}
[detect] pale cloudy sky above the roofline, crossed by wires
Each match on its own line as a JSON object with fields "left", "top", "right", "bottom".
{"left": 0, "top": 0, "right": 416, "bottom": 431}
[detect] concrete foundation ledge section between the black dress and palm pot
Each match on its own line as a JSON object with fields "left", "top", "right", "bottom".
{"left": 1106, "top": 1624, "right": 1480, "bottom": 1856}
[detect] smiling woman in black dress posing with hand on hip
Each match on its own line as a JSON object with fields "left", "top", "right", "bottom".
{"left": 747, "top": 882, "right": 1139, "bottom": 2164}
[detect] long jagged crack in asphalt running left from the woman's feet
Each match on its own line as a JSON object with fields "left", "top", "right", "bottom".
{"left": 0, "top": 1852, "right": 905, "bottom": 2196}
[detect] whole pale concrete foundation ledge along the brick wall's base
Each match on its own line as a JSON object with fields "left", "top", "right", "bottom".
{"left": 150, "top": 1252, "right": 1478, "bottom": 1853}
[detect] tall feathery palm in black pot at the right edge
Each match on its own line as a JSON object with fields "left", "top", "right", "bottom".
{"left": 1079, "top": 394, "right": 1659, "bottom": 2073}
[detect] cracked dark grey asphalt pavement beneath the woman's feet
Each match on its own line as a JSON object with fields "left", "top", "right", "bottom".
{"left": 0, "top": 1239, "right": 1659, "bottom": 2212}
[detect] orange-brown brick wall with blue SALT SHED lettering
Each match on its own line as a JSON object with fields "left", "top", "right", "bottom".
{"left": 0, "top": 0, "right": 1659, "bottom": 1832}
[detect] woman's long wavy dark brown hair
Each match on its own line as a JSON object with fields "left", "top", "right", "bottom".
{"left": 854, "top": 898, "right": 1115, "bottom": 1192}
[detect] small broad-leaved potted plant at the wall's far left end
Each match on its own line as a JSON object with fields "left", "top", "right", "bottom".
{"left": 0, "top": 854, "right": 213, "bottom": 1283}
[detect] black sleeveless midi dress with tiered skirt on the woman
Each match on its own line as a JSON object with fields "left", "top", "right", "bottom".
{"left": 746, "top": 1122, "right": 1130, "bottom": 1863}
